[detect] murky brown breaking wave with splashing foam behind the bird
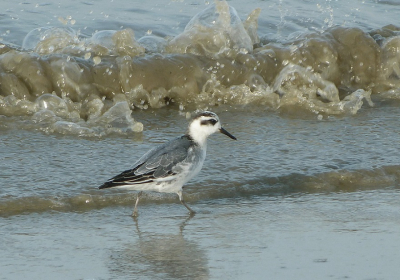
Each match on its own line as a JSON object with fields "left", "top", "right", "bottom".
{"left": 0, "top": 1, "right": 400, "bottom": 136}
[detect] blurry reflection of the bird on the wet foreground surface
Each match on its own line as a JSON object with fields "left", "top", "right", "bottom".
{"left": 110, "top": 215, "right": 209, "bottom": 279}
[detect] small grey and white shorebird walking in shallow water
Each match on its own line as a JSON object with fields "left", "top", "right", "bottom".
{"left": 99, "top": 111, "right": 236, "bottom": 216}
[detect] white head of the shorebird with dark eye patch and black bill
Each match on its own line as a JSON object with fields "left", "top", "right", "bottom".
{"left": 188, "top": 111, "right": 236, "bottom": 146}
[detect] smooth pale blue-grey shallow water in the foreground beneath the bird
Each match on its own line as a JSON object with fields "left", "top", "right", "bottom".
{"left": 1, "top": 189, "right": 400, "bottom": 279}
